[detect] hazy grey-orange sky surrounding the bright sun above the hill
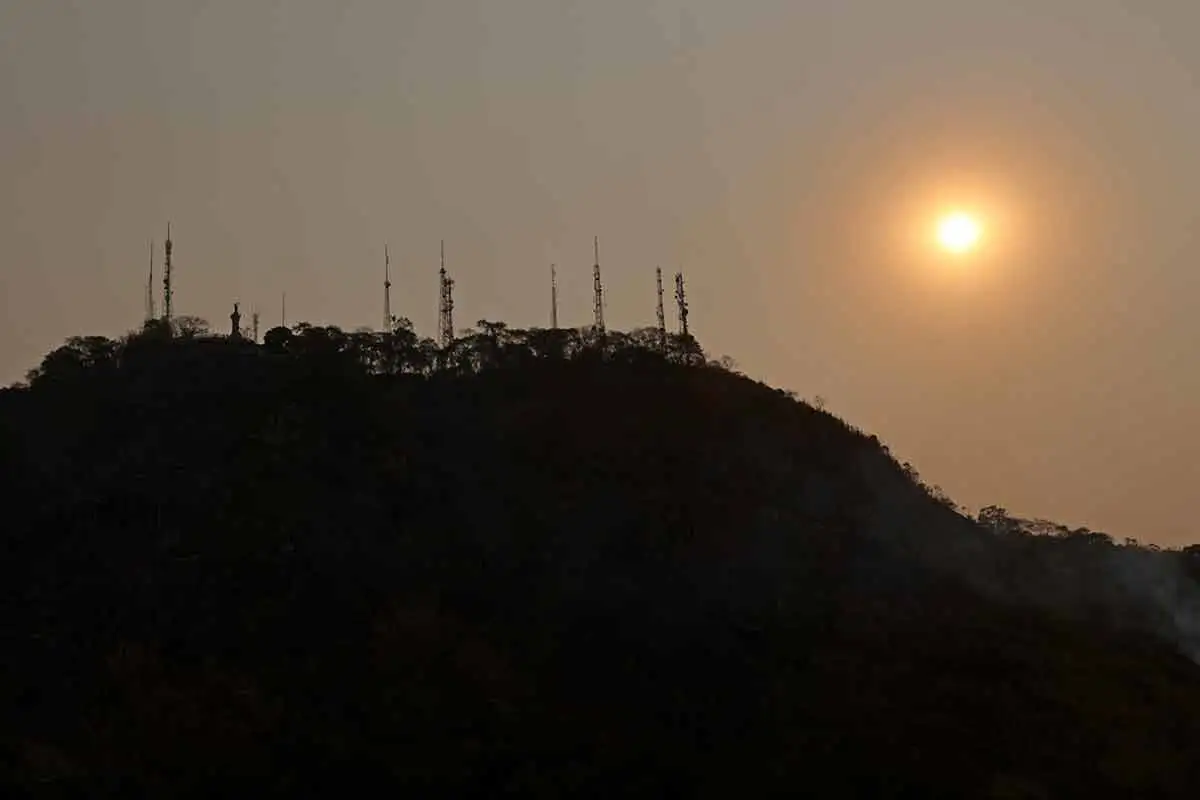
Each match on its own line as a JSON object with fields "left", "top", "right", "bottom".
{"left": 0, "top": 0, "right": 1200, "bottom": 543}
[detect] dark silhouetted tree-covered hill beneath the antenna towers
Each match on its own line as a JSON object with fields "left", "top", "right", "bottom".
{"left": 0, "top": 321, "right": 1200, "bottom": 798}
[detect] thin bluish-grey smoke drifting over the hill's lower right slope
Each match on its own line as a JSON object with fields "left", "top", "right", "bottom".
{"left": 859, "top": 449, "right": 1200, "bottom": 663}
